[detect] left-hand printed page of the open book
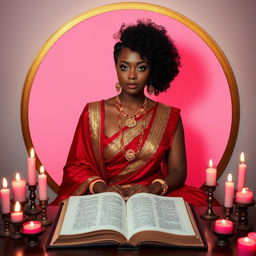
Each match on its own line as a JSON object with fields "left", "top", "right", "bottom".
{"left": 60, "top": 192, "right": 126, "bottom": 235}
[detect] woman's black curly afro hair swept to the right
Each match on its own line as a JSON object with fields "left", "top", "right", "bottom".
{"left": 114, "top": 20, "right": 180, "bottom": 95}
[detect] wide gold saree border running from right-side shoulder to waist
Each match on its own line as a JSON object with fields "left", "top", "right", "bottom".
{"left": 111, "top": 104, "right": 171, "bottom": 181}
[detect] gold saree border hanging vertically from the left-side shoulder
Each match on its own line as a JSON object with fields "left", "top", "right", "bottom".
{"left": 88, "top": 101, "right": 103, "bottom": 170}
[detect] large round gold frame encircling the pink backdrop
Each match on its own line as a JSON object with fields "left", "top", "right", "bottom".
{"left": 21, "top": 2, "right": 240, "bottom": 192}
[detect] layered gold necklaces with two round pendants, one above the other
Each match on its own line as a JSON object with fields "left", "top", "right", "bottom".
{"left": 116, "top": 96, "right": 148, "bottom": 161}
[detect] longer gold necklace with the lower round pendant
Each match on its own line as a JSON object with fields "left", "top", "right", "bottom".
{"left": 116, "top": 97, "right": 147, "bottom": 162}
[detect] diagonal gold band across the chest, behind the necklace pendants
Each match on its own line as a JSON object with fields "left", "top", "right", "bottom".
{"left": 104, "top": 111, "right": 153, "bottom": 159}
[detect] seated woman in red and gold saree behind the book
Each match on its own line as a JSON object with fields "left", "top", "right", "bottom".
{"left": 54, "top": 20, "right": 210, "bottom": 205}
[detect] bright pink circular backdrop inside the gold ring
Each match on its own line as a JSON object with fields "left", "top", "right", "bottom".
{"left": 28, "top": 10, "right": 232, "bottom": 186}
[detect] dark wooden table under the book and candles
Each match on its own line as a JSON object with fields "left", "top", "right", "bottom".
{"left": 0, "top": 206, "right": 256, "bottom": 256}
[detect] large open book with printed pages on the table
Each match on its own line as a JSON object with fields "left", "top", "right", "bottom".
{"left": 48, "top": 192, "right": 205, "bottom": 248}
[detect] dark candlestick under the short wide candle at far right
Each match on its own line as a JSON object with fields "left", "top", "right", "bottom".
{"left": 237, "top": 201, "right": 255, "bottom": 231}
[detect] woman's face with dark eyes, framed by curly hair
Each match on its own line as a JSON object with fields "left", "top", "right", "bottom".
{"left": 116, "top": 48, "right": 150, "bottom": 94}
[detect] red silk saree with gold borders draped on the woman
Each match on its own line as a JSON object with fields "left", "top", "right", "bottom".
{"left": 53, "top": 100, "right": 210, "bottom": 206}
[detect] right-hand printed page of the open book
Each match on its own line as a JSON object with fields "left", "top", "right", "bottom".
{"left": 127, "top": 193, "right": 195, "bottom": 239}
